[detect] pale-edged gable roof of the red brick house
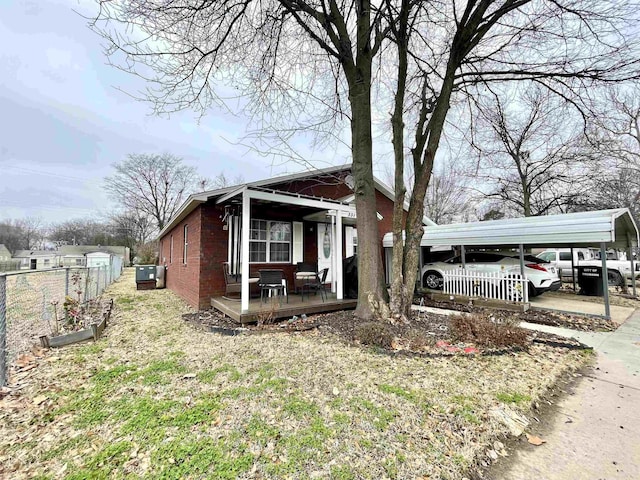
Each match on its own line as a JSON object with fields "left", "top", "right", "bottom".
{"left": 158, "top": 164, "right": 435, "bottom": 238}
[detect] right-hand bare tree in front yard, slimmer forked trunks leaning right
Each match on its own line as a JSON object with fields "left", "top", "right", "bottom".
{"left": 385, "top": 0, "right": 639, "bottom": 318}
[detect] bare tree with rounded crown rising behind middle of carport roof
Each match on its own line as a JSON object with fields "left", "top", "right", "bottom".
{"left": 474, "top": 85, "right": 593, "bottom": 217}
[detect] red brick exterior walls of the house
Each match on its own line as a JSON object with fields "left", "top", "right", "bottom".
{"left": 160, "top": 171, "right": 402, "bottom": 309}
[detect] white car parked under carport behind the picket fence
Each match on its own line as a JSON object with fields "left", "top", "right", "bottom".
{"left": 422, "top": 252, "right": 562, "bottom": 297}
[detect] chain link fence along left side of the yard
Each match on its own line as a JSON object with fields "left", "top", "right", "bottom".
{"left": 0, "top": 256, "right": 122, "bottom": 387}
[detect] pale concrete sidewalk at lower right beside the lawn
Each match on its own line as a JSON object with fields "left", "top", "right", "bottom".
{"left": 498, "top": 311, "right": 640, "bottom": 480}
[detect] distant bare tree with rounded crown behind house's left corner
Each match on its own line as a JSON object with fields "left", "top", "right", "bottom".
{"left": 105, "top": 153, "right": 199, "bottom": 230}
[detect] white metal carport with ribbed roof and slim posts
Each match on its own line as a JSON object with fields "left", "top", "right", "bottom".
{"left": 383, "top": 208, "right": 639, "bottom": 319}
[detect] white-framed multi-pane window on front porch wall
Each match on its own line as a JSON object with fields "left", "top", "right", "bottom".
{"left": 249, "top": 220, "right": 291, "bottom": 263}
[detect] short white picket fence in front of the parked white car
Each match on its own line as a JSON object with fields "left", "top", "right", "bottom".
{"left": 442, "top": 268, "right": 529, "bottom": 303}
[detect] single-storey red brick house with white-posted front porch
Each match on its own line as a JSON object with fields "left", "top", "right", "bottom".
{"left": 159, "top": 165, "right": 433, "bottom": 321}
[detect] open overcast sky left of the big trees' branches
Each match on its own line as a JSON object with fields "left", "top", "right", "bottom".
{"left": 0, "top": 0, "right": 352, "bottom": 223}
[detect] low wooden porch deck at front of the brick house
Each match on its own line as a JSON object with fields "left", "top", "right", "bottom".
{"left": 211, "top": 292, "right": 358, "bottom": 323}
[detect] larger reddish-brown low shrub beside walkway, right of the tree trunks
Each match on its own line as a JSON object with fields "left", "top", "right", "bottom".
{"left": 450, "top": 314, "right": 528, "bottom": 348}
